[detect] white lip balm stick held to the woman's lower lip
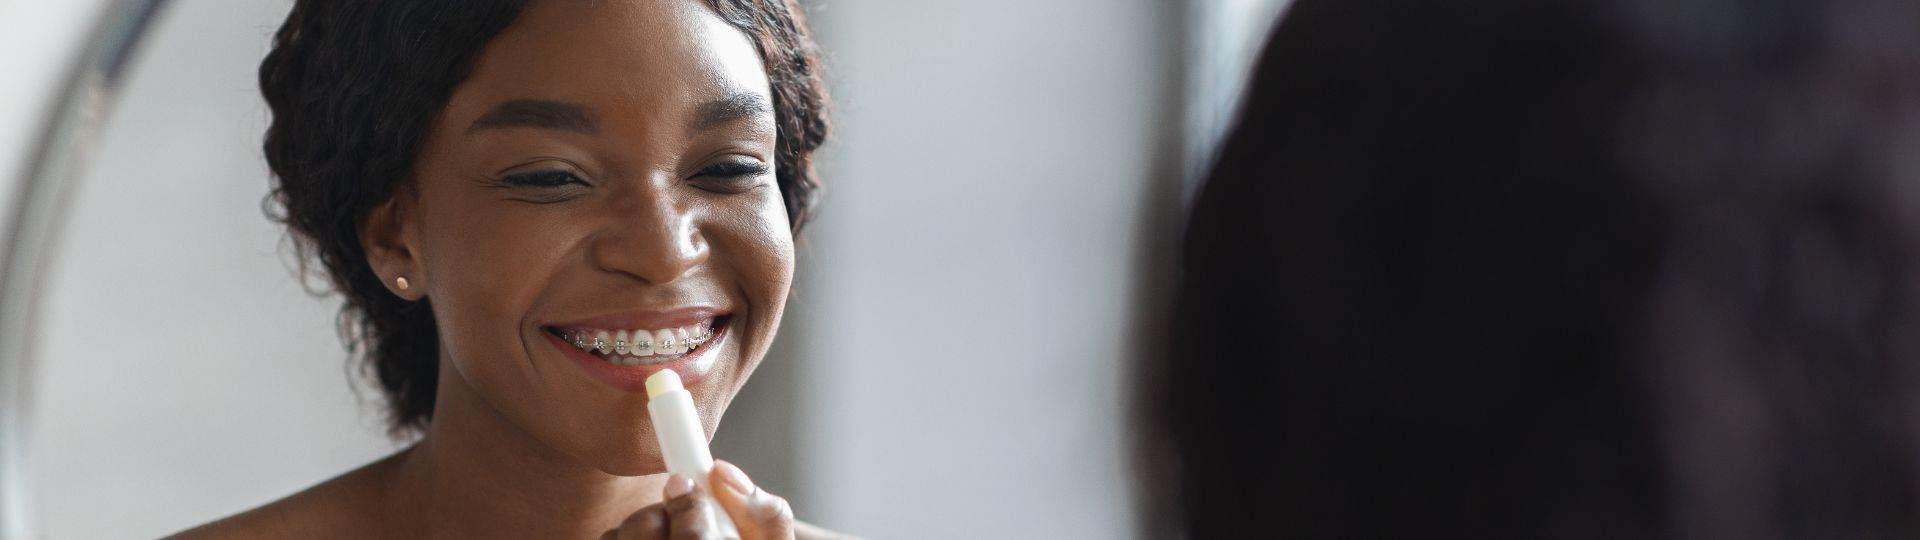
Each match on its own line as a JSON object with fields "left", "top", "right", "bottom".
{"left": 647, "top": 369, "right": 739, "bottom": 536}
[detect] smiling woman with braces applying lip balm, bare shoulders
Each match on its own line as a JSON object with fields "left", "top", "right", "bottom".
{"left": 182, "top": 0, "right": 826, "bottom": 538}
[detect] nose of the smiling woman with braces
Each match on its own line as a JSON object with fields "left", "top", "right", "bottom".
{"left": 593, "top": 190, "right": 708, "bottom": 282}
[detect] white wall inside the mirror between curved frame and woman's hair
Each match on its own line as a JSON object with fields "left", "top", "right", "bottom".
{"left": 27, "top": 0, "right": 403, "bottom": 538}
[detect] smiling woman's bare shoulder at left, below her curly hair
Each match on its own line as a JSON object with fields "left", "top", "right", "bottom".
{"left": 169, "top": 455, "right": 399, "bottom": 538}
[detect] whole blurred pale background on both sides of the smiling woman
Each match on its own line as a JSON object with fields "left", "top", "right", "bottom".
{"left": 0, "top": 0, "right": 1286, "bottom": 538}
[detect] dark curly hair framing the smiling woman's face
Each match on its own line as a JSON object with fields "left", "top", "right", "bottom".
{"left": 259, "top": 0, "right": 828, "bottom": 436}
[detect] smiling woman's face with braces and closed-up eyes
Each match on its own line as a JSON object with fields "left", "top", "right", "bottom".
{"left": 394, "top": 0, "right": 793, "bottom": 475}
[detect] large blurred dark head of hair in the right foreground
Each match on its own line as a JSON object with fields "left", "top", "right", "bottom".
{"left": 1150, "top": 0, "right": 1920, "bottom": 538}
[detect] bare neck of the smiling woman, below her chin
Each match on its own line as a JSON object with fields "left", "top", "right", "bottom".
{"left": 384, "top": 363, "right": 666, "bottom": 538}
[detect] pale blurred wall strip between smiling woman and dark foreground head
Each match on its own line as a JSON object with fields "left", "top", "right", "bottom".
{"left": 795, "top": 0, "right": 1181, "bottom": 538}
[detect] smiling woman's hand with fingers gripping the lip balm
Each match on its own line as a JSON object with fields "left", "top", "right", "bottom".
{"left": 601, "top": 461, "right": 795, "bottom": 540}
